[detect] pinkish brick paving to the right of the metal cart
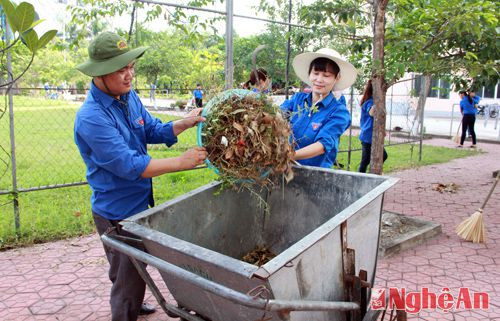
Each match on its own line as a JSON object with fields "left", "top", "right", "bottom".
{"left": 376, "top": 139, "right": 500, "bottom": 321}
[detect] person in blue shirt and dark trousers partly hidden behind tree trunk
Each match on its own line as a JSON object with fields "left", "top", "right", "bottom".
{"left": 359, "top": 79, "right": 387, "bottom": 173}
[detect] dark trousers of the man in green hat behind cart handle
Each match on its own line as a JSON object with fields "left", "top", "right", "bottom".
{"left": 92, "top": 213, "right": 146, "bottom": 321}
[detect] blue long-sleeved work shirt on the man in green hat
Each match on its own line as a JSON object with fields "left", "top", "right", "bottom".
{"left": 74, "top": 82, "right": 177, "bottom": 220}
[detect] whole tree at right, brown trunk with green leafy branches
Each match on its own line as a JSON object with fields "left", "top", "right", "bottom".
{"left": 301, "top": 0, "right": 499, "bottom": 174}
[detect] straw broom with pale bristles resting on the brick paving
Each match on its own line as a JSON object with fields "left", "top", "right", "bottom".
{"left": 456, "top": 172, "right": 500, "bottom": 243}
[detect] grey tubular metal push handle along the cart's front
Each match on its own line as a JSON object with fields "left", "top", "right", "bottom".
{"left": 101, "top": 235, "right": 359, "bottom": 311}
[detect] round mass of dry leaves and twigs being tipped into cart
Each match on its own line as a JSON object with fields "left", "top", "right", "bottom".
{"left": 201, "top": 91, "right": 294, "bottom": 184}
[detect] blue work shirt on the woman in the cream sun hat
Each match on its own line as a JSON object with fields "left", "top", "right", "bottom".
{"left": 281, "top": 92, "right": 351, "bottom": 168}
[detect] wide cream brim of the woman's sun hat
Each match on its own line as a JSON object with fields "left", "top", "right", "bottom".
{"left": 292, "top": 52, "right": 358, "bottom": 91}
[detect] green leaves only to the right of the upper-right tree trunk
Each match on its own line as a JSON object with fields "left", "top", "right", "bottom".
{"left": 385, "top": 0, "right": 499, "bottom": 87}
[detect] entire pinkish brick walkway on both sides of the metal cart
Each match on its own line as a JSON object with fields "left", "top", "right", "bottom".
{"left": 0, "top": 140, "right": 500, "bottom": 321}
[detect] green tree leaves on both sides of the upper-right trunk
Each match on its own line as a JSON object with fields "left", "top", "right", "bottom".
{"left": 299, "top": 0, "right": 500, "bottom": 87}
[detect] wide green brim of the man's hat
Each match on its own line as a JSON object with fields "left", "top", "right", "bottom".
{"left": 76, "top": 47, "right": 148, "bottom": 77}
